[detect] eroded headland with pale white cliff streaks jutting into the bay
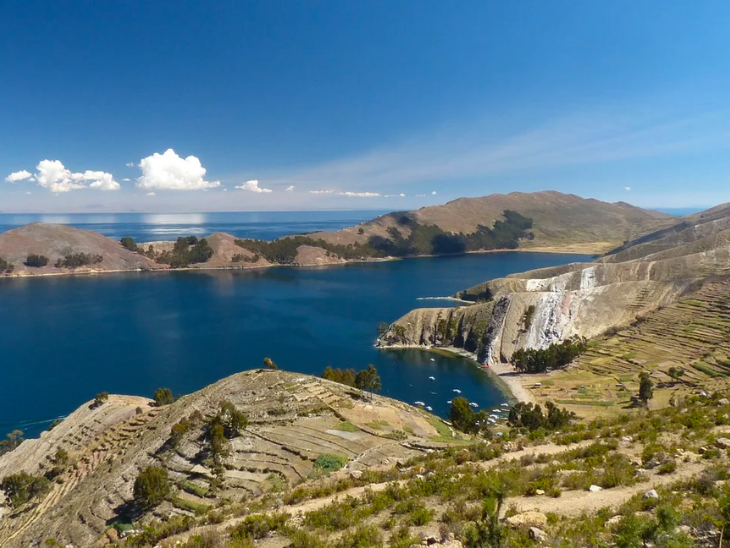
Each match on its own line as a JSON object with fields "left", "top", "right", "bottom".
{"left": 380, "top": 203, "right": 730, "bottom": 363}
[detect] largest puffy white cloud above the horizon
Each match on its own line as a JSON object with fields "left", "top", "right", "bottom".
{"left": 137, "top": 148, "right": 221, "bottom": 190}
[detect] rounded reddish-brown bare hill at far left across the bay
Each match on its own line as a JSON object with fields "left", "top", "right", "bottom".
{"left": 0, "top": 223, "right": 163, "bottom": 275}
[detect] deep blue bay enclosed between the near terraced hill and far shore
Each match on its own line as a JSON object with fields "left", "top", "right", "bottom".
{"left": 0, "top": 252, "right": 591, "bottom": 436}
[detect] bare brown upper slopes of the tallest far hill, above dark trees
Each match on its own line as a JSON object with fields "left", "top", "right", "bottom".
{"left": 312, "top": 191, "right": 673, "bottom": 253}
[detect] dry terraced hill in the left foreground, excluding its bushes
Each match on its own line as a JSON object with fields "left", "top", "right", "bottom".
{"left": 0, "top": 370, "right": 450, "bottom": 548}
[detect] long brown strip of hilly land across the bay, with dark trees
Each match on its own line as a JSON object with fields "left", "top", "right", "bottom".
{"left": 0, "top": 191, "right": 672, "bottom": 276}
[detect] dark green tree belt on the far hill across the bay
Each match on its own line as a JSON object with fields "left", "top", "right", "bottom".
{"left": 236, "top": 210, "right": 532, "bottom": 264}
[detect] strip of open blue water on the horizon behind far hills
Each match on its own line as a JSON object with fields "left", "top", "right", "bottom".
{"left": 0, "top": 210, "right": 386, "bottom": 242}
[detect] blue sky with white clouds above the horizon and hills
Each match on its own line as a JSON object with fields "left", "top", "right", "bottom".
{"left": 0, "top": 0, "right": 730, "bottom": 213}
